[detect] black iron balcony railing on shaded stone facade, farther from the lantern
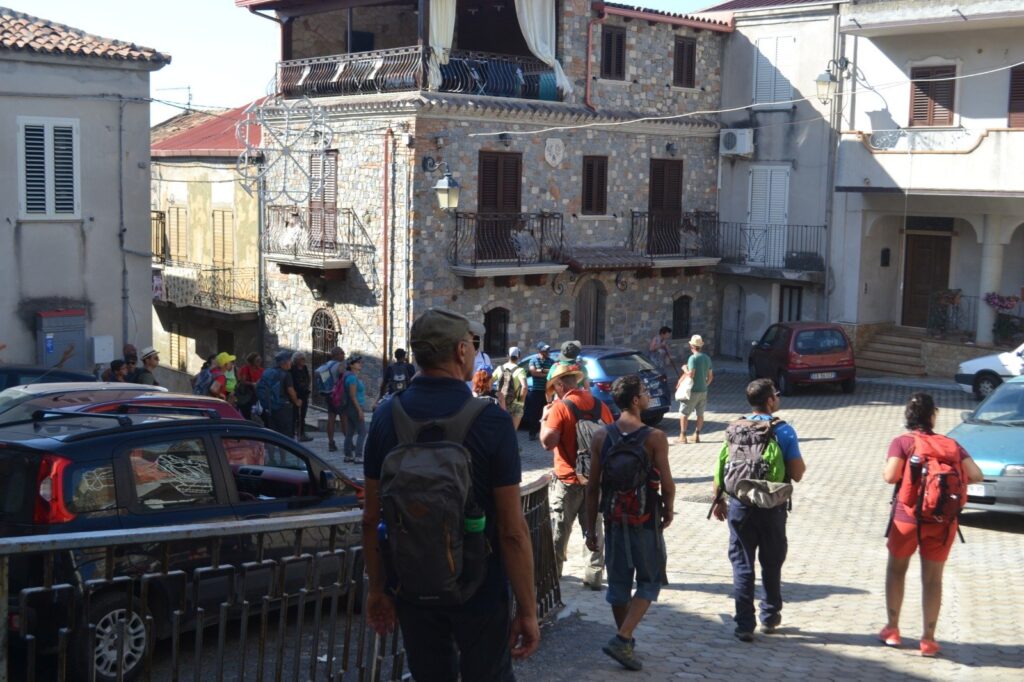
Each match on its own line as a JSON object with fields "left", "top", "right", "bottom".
{"left": 630, "top": 211, "right": 720, "bottom": 259}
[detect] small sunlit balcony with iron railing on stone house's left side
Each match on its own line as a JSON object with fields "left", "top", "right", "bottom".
{"left": 260, "top": 206, "right": 358, "bottom": 274}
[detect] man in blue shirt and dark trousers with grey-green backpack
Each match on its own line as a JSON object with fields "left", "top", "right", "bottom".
{"left": 708, "top": 379, "right": 807, "bottom": 642}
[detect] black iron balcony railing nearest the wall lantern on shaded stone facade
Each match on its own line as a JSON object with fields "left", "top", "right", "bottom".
{"left": 449, "top": 213, "right": 562, "bottom": 267}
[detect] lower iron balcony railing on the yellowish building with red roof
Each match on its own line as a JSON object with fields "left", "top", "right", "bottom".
{"left": 154, "top": 261, "right": 259, "bottom": 314}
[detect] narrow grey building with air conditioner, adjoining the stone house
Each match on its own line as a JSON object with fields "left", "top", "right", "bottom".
{"left": 706, "top": 0, "right": 845, "bottom": 357}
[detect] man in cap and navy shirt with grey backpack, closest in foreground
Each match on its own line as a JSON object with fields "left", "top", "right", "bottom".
{"left": 362, "top": 308, "right": 541, "bottom": 682}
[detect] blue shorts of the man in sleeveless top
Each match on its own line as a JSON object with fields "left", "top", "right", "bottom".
{"left": 604, "top": 523, "right": 669, "bottom": 606}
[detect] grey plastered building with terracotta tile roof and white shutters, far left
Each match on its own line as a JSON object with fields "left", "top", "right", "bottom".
{"left": 0, "top": 7, "right": 170, "bottom": 369}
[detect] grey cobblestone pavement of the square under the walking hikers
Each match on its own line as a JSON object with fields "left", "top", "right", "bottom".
{"left": 299, "top": 374, "right": 1024, "bottom": 682}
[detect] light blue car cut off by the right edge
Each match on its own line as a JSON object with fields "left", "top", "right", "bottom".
{"left": 948, "top": 377, "right": 1024, "bottom": 514}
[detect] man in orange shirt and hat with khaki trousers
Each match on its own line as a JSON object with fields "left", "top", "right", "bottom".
{"left": 541, "top": 365, "right": 614, "bottom": 590}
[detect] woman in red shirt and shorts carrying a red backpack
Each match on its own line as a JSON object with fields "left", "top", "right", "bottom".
{"left": 879, "top": 393, "right": 984, "bottom": 656}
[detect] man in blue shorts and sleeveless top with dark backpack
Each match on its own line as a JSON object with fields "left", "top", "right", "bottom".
{"left": 586, "top": 375, "right": 676, "bottom": 670}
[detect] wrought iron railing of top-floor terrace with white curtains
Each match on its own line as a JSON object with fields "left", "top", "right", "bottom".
{"left": 278, "top": 46, "right": 559, "bottom": 100}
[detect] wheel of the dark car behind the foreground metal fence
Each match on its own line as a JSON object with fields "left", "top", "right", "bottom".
{"left": 71, "top": 592, "right": 150, "bottom": 682}
